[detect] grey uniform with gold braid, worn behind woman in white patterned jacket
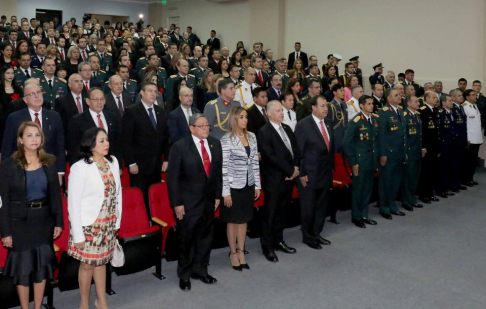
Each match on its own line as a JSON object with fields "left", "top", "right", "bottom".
{"left": 204, "top": 97, "right": 240, "bottom": 140}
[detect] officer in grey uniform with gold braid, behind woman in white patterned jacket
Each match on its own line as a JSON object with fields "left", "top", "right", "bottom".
{"left": 204, "top": 79, "right": 241, "bottom": 139}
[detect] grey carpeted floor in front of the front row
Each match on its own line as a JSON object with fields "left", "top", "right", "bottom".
{"left": 43, "top": 172, "right": 486, "bottom": 309}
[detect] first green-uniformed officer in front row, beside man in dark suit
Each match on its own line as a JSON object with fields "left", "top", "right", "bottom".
{"left": 342, "top": 95, "right": 378, "bottom": 228}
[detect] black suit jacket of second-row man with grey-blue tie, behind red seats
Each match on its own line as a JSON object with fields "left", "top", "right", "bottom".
{"left": 122, "top": 102, "right": 169, "bottom": 175}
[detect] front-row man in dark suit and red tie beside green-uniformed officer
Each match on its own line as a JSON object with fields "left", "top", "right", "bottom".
{"left": 295, "top": 95, "right": 334, "bottom": 249}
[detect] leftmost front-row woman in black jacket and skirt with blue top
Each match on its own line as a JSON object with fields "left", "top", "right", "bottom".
{"left": 0, "top": 122, "right": 63, "bottom": 309}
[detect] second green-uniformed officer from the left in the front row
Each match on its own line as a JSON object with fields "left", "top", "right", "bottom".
{"left": 378, "top": 89, "right": 406, "bottom": 220}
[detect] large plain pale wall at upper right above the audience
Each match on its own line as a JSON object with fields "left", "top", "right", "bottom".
{"left": 285, "top": 0, "right": 485, "bottom": 91}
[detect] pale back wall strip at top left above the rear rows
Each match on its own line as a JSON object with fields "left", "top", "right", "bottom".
{"left": 17, "top": 0, "right": 148, "bottom": 25}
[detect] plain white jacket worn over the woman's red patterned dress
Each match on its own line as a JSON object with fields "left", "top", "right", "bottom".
{"left": 68, "top": 156, "right": 122, "bottom": 243}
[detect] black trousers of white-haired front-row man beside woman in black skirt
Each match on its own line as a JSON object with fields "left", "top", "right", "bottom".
{"left": 260, "top": 181, "right": 293, "bottom": 248}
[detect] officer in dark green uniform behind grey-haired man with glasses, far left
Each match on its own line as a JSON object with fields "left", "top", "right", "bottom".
{"left": 39, "top": 58, "right": 69, "bottom": 109}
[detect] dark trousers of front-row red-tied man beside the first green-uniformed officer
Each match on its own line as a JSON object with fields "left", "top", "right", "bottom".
{"left": 298, "top": 184, "right": 329, "bottom": 243}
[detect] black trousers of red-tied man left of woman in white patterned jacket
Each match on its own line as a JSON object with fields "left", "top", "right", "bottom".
{"left": 174, "top": 200, "right": 214, "bottom": 280}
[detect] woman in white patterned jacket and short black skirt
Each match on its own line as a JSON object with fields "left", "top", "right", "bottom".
{"left": 220, "top": 107, "right": 261, "bottom": 271}
